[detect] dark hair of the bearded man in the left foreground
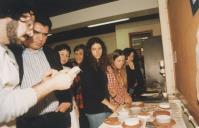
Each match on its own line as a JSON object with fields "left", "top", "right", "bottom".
{"left": 0, "top": 0, "right": 36, "bottom": 20}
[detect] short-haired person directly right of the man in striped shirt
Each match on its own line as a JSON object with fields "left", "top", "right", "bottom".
{"left": 55, "top": 44, "right": 79, "bottom": 128}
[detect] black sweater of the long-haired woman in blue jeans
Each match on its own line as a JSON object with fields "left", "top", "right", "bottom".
{"left": 80, "top": 65, "right": 108, "bottom": 114}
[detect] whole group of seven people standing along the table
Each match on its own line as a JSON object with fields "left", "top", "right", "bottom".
{"left": 0, "top": 1, "right": 144, "bottom": 128}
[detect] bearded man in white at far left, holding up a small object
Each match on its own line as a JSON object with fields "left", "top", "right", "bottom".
{"left": 0, "top": 0, "right": 79, "bottom": 127}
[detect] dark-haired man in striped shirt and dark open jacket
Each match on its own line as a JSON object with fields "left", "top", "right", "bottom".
{"left": 13, "top": 15, "right": 72, "bottom": 128}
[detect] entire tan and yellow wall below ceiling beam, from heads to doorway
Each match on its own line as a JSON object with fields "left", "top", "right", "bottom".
{"left": 50, "top": 19, "right": 161, "bottom": 57}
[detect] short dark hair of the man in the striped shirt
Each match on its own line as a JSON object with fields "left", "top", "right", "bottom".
{"left": 35, "top": 13, "right": 52, "bottom": 31}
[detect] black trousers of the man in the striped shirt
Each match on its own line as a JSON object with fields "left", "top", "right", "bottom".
{"left": 17, "top": 112, "right": 71, "bottom": 128}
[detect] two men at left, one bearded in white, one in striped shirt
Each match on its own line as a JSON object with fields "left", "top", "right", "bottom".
{"left": 0, "top": 1, "right": 80, "bottom": 128}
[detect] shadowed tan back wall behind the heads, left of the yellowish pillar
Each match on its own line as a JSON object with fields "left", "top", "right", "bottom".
{"left": 51, "top": 33, "right": 116, "bottom": 57}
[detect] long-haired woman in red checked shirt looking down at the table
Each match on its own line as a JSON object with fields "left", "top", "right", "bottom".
{"left": 107, "top": 49, "right": 132, "bottom": 106}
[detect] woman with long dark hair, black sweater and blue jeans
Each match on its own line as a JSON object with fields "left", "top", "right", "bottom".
{"left": 81, "top": 37, "right": 116, "bottom": 128}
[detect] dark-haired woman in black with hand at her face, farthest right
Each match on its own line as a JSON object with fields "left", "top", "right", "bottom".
{"left": 124, "top": 48, "right": 145, "bottom": 96}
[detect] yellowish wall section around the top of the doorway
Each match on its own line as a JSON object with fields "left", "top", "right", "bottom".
{"left": 116, "top": 19, "right": 161, "bottom": 49}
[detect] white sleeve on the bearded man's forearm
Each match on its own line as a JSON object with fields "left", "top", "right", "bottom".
{"left": 0, "top": 88, "right": 37, "bottom": 123}
